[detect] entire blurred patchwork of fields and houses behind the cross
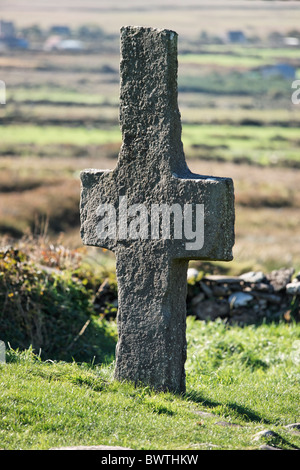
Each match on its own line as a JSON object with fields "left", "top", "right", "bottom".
{"left": 0, "top": 0, "right": 300, "bottom": 272}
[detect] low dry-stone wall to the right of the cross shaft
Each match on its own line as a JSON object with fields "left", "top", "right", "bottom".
{"left": 187, "top": 268, "right": 300, "bottom": 324}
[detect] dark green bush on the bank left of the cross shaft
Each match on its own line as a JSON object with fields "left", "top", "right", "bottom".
{"left": 0, "top": 248, "right": 115, "bottom": 362}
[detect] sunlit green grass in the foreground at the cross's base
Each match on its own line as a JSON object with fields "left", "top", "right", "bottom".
{"left": 0, "top": 317, "right": 300, "bottom": 450}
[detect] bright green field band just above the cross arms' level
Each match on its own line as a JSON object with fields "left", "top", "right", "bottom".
{"left": 1, "top": 124, "right": 300, "bottom": 165}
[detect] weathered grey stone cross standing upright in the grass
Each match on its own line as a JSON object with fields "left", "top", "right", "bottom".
{"left": 81, "top": 26, "right": 234, "bottom": 393}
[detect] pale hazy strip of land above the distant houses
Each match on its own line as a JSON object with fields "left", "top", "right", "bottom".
{"left": 1, "top": 0, "right": 300, "bottom": 36}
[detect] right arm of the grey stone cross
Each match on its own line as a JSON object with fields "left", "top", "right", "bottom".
{"left": 171, "top": 173, "right": 235, "bottom": 261}
